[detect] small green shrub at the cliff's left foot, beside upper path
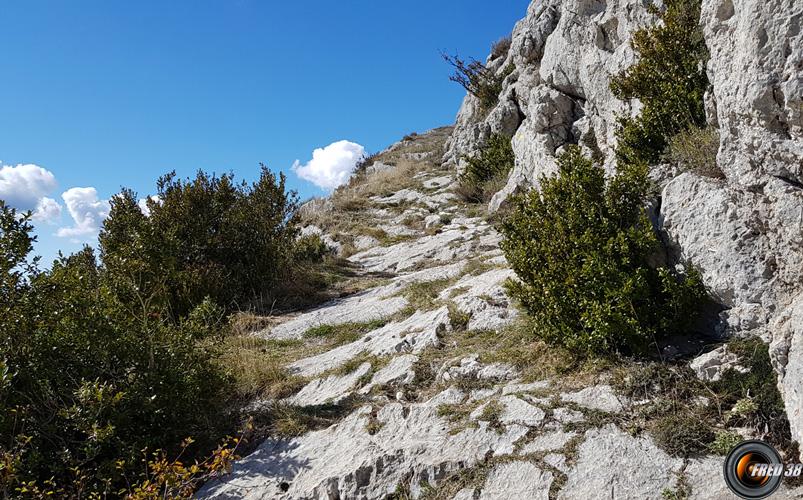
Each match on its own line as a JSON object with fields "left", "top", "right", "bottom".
{"left": 458, "top": 134, "right": 516, "bottom": 202}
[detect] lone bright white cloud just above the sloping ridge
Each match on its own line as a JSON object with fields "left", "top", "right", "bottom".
{"left": 293, "top": 141, "right": 365, "bottom": 190}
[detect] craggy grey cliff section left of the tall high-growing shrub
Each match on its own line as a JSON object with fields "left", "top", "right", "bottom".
{"left": 444, "top": 0, "right": 653, "bottom": 209}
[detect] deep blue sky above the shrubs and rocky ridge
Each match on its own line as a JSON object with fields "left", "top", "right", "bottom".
{"left": 0, "top": 0, "right": 529, "bottom": 266}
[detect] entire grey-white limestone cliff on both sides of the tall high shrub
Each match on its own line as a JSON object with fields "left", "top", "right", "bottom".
{"left": 444, "top": 0, "right": 803, "bottom": 450}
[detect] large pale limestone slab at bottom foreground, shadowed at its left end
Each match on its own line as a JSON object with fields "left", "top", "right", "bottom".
{"left": 200, "top": 403, "right": 532, "bottom": 499}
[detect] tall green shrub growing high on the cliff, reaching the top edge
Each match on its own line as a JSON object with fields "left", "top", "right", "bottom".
{"left": 611, "top": 0, "right": 708, "bottom": 164}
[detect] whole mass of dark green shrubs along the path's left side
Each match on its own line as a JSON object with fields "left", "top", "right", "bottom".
{"left": 0, "top": 168, "right": 312, "bottom": 498}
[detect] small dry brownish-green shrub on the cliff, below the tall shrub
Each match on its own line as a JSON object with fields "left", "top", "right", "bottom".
{"left": 664, "top": 127, "right": 725, "bottom": 179}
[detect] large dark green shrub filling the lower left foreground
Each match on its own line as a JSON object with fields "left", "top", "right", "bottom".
{"left": 0, "top": 206, "right": 234, "bottom": 496}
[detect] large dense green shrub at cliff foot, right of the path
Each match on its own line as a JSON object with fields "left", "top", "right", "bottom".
{"left": 501, "top": 146, "right": 705, "bottom": 353}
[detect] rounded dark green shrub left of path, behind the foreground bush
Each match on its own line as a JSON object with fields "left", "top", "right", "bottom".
{"left": 100, "top": 166, "right": 298, "bottom": 320}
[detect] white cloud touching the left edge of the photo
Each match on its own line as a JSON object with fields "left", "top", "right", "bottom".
{"left": 0, "top": 163, "right": 61, "bottom": 221}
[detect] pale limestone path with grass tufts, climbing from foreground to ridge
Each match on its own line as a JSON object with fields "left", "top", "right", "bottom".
{"left": 199, "top": 127, "right": 744, "bottom": 500}
